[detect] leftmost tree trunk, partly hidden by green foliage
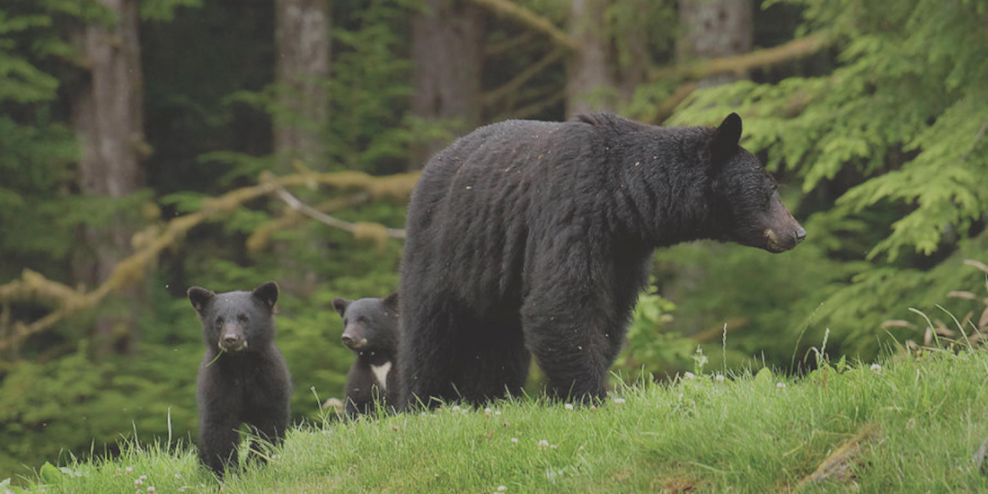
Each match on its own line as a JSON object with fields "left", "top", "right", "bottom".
{"left": 72, "top": 0, "right": 149, "bottom": 355}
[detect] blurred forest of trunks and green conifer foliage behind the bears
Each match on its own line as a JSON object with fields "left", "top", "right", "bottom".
{"left": 0, "top": 0, "right": 988, "bottom": 478}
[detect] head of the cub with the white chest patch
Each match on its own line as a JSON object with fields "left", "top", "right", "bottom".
{"left": 333, "top": 292, "right": 398, "bottom": 354}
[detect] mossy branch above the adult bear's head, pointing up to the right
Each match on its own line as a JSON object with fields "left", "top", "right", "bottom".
{"left": 649, "top": 34, "right": 833, "bottom": 81}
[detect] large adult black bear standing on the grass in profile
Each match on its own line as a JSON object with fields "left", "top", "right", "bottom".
{"left": 399, "top": 113, "right": 806, "bottom": 406}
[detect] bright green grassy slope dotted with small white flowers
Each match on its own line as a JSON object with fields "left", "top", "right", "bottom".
{"left": 0, "top": 350, "right": 988, "bottom": 494}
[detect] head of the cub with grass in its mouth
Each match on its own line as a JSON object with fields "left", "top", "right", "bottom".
{"left": 188, "top": 281, "right": 278, "bottom": 353}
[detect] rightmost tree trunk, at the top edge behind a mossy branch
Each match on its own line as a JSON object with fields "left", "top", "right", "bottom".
{"left": 676, "top": 0, "right": 755, "bottom": 87}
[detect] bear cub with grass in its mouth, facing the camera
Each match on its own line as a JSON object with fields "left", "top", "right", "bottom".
{"left": 188, "top": 281, "right": 292, "bottom": 477}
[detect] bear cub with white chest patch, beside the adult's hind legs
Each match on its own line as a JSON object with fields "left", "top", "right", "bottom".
{"left": 333, "top": 293, "right": 400, "bottom": 418}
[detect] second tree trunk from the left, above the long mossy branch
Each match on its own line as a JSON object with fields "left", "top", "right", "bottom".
{"left": 274, "top": 0, "right": 330, "bottom": 171}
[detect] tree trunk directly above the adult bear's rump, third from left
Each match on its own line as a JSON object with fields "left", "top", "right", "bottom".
{"left": 409, "top": 0, "right": 487, "bottom": 170}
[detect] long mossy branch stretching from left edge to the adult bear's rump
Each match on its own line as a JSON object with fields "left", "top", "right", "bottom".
{"left": 0, "top": 172, "right": 418, "bottom": 350}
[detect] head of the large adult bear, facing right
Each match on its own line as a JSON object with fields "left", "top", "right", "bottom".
{"left": 706, "top": 113, "right": 806, "bottom": 253}
